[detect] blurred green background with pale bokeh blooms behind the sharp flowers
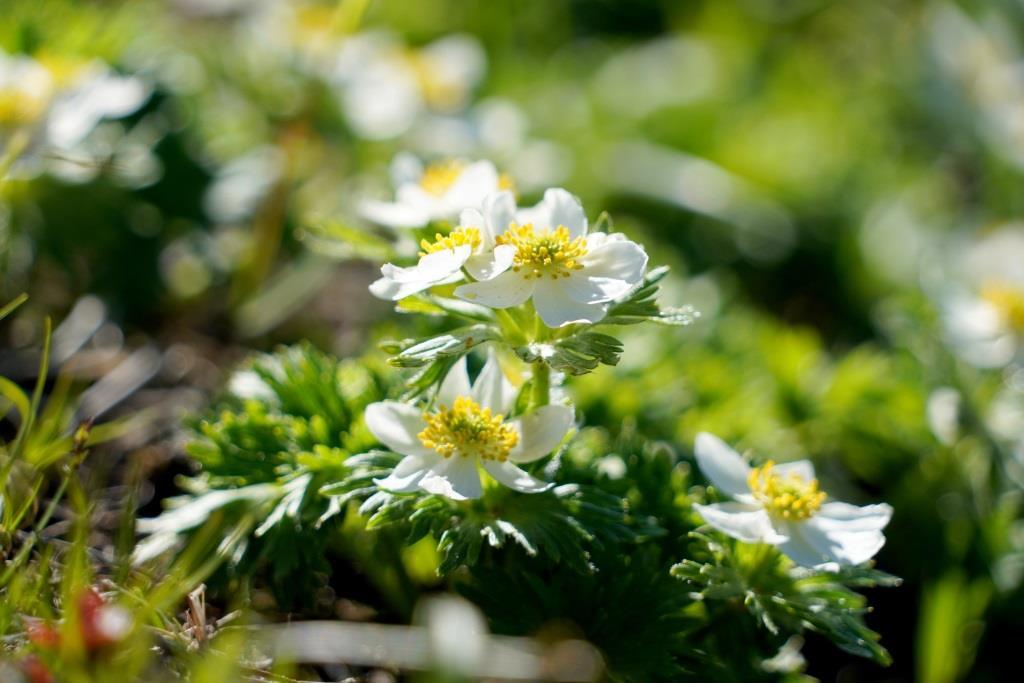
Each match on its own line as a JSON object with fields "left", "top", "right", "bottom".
{"left": 0, "top": 0, "right": 1024, "bottom": 683}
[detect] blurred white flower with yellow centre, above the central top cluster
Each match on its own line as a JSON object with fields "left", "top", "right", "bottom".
{"left": 328, "top": 33, "right": 486, "bottom": 139}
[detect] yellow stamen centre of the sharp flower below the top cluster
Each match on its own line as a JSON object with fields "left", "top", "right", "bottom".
{"left": 417, "top": 396, "right": 519, "bottom": 462}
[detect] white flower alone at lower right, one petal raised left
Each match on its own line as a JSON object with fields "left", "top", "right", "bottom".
{"left": 693, "top": 433, "right": 893, "bottom": 569}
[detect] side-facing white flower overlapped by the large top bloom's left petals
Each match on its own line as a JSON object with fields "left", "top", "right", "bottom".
{"left": 370, "top": 193, "right": 515, "bottom": 301}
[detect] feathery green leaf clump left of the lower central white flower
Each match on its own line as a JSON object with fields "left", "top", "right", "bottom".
{"left": 135, "top": 345, "right": 381, "bottom": 605}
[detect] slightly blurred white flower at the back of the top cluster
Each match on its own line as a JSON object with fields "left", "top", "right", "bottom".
{"left": 359, "top": 154, "right": 509, "bottom": 227}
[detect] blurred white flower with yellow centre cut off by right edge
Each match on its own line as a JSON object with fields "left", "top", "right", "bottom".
{"left": 943, "top": 225, "right": 1024, "bottom": 368}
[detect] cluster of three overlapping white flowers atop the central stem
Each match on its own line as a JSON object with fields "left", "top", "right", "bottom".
{"left": 364, "top": 154, "right": 647, "bottom": 328}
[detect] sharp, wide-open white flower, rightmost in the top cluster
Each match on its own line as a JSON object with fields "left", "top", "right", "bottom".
{"left": 456, "top": 188, "right": 647, "bottom": 328}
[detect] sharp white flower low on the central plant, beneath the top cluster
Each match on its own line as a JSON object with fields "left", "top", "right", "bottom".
{"left": 366, "top": 354, "right": 573, "bottom": 501}
